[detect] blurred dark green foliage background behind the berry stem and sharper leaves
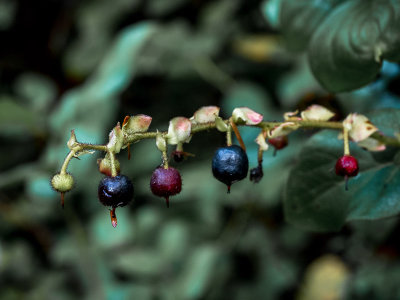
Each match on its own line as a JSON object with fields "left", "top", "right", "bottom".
{"left": 0, "top": 0, "right": 400, "bottom": 300}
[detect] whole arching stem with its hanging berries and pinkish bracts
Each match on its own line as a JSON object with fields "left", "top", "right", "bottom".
{"left": 51, "top": 105, "right": 384, "bottom": 227}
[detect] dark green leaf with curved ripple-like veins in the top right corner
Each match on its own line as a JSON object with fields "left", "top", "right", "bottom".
{"left": 308, "top": 0, "right": 400, "bottom": 92}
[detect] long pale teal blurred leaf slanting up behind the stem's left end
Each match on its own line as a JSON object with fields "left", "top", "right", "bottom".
{"left": 45, "top": 22, "right": 156, "bottom": 184}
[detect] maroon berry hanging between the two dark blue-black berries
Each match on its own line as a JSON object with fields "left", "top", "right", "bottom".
{"left": 150, "top": 167, "right": 182, "bottom": 207}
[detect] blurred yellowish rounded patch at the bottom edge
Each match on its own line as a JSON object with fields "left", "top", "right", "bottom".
{"left": 297, "top": 255, "right": 349, "bottom": 300}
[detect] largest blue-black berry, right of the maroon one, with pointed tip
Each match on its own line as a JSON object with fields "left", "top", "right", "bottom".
{"left": 212, "top": 145, "right": 249, "bottom": 193}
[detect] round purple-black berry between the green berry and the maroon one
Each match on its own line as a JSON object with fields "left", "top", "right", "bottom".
{"left": 98, "top": 175, "right": 133, "bottom": 208}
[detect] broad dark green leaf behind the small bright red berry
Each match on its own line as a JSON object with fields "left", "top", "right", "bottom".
{"left": 284, "top": 131, "right": 400, "bottom": 231}
